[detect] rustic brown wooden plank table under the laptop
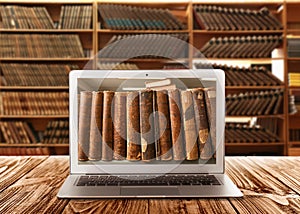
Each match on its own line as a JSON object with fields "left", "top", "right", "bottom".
{"left": 0, "top": 156, "right": 300, "bottom": 214}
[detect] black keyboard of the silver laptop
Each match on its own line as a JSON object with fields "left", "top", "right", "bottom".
{"left": 76, "top": 175, "right": 221, "bottom": 186}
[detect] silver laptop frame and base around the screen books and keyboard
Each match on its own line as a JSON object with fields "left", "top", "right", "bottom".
{"left": 57, "top": 69, "right": 242, "bottom": 198}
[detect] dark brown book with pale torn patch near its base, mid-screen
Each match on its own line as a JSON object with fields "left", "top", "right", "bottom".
{"left": 140, "top": 89, "right": 156, "bottom": 161}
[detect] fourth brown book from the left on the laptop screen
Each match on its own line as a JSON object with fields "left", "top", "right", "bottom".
{"left": 113, "top": 92, "right": 127, "bottom": 160}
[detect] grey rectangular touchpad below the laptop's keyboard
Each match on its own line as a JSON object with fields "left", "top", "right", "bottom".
{"left": 121, "top": 186, "right": 179, "bottom": 196}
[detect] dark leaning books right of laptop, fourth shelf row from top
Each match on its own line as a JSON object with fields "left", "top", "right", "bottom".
{"left": 226, "top": 90, "right": 283, "bottom": 116}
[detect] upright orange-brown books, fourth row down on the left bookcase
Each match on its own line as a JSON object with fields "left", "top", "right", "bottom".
{"left": 0, "top": 91, "right": 69, "bottom": 115}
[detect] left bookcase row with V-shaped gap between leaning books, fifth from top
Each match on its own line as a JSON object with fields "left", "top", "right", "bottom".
{"left": 0, "top": 120, "right": 69, "bottom": 144}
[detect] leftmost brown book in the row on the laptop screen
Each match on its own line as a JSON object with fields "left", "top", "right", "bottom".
{"left": 78, "top": 91, "right": 92, "bottom": 160}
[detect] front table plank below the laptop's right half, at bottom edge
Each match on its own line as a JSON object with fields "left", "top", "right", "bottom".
{"left": 149, "top": 199, "right": 236, "bottom": 214}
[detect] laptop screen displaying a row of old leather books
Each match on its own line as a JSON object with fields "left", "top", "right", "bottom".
{"left": 76, "top": 74, "right": 217, "bottom": 166}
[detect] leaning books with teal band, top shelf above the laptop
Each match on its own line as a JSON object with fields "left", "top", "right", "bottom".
{"left": 98, "top": 4, "right": 186, "bottom": 30}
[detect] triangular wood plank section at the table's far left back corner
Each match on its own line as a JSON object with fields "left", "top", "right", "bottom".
{"left": 0, "top": 156, "right": 47, "bottom": 192}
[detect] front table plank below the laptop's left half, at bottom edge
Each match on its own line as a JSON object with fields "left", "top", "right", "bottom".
{"left": 63, "top": 199, "right": 148, "bottom": 214}
